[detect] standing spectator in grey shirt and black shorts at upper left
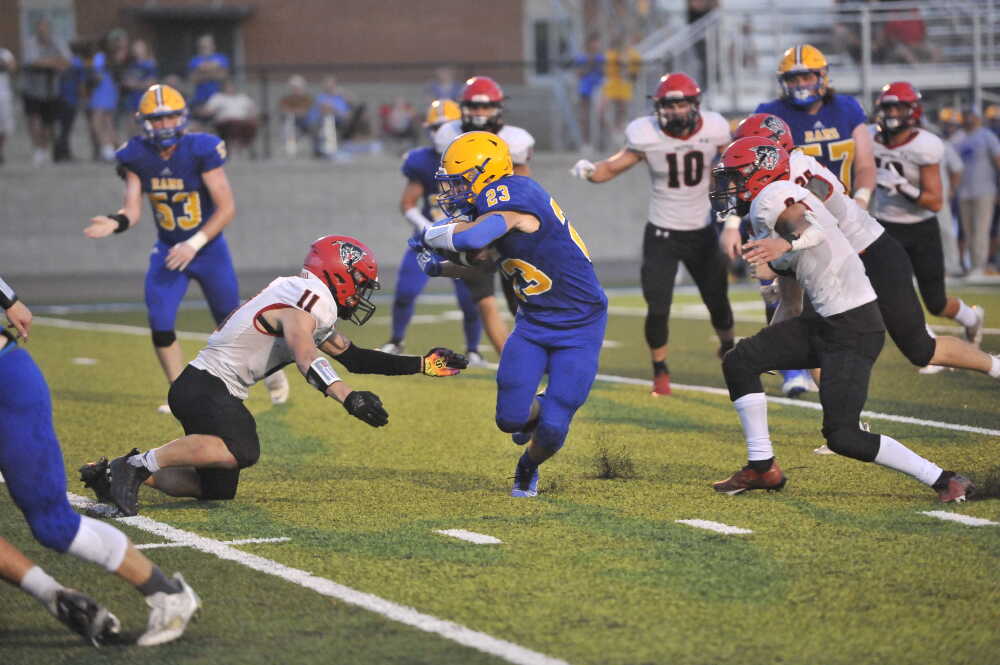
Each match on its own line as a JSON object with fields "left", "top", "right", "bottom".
{"left": 20, "top": 17, "right": 70, "bottom": 166}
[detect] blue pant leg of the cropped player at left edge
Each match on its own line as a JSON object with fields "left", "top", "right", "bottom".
{"left": 0, "top": 345, "right": 80, "bottom": 552}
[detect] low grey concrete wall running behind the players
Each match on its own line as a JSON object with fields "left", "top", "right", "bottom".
{"left": 0, "top": 154, "right": 649, "bottom": 302}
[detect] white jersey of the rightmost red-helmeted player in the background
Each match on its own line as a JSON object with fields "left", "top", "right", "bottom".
{"left": 872, "top": 128, "right": 944, "bottom": 224}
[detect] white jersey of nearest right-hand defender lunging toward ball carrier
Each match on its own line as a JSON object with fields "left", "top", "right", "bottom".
{"left": 750, "top": 180, "right": 875, "bottom": 318}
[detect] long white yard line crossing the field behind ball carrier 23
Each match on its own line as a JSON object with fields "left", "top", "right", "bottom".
{"left": 33, "top": 316, "right": 1000, "bottom": 436}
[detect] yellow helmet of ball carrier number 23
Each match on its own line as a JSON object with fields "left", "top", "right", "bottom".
{"left": 434, "top": 132, "right": 514, "bottom": 217}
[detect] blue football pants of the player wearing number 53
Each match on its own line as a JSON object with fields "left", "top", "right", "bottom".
{"left": 146, "top": 236, "right": 240, "bottom": 331}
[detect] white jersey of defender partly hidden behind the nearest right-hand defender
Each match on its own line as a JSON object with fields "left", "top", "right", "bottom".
{"left": 788, "top": 150, "right": 885, "bottom": 252}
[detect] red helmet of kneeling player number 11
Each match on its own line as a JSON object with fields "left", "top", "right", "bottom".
{"left": 302, "top": 236, "right": 380, "bottom": 326}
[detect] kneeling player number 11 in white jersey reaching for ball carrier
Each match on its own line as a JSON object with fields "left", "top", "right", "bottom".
{"left": 80, "top": 236, "right": 467, "bottom": 515}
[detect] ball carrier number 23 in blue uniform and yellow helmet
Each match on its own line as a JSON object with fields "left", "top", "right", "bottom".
{"left": 422, "top": 132, "right": 608, "bottom": 497}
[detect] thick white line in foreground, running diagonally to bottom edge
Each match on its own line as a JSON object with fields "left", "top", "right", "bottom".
{"left": 67, "top": 492, "right": 569, "bottom": 665}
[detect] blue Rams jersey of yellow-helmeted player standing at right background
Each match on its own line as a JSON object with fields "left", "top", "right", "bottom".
{"left": 754, "top": 95, "right": 868, "bottom": 193}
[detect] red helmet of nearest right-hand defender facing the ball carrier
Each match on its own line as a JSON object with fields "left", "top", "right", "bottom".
{"left": 709, "top": 136, "right": 789, "bottom": 216}
